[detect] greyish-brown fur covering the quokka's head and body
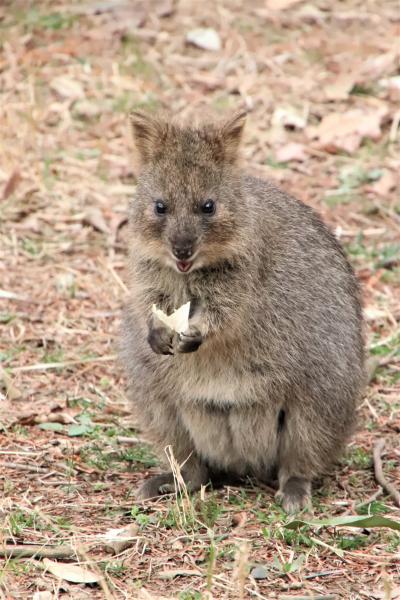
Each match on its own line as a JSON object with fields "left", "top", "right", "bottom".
{"left": 123, "top": 113, "right": 364, "bottom": 511}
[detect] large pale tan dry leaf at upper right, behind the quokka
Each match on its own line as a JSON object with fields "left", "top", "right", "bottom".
{"left": 306, "top": 106, "right": 387, "bottom": 154}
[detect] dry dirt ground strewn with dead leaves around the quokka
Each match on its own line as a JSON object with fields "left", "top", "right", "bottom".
{"left": 0, "top": 0, "right": 400, "bottom": 600}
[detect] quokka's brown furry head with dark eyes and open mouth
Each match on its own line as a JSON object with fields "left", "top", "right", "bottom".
{"left": 131, "top": 112, "right": 245, "bottom": 273}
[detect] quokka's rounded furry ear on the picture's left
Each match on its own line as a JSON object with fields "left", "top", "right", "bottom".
{"left": 129, "top": 110, "right": 168, "bottom": 165}
